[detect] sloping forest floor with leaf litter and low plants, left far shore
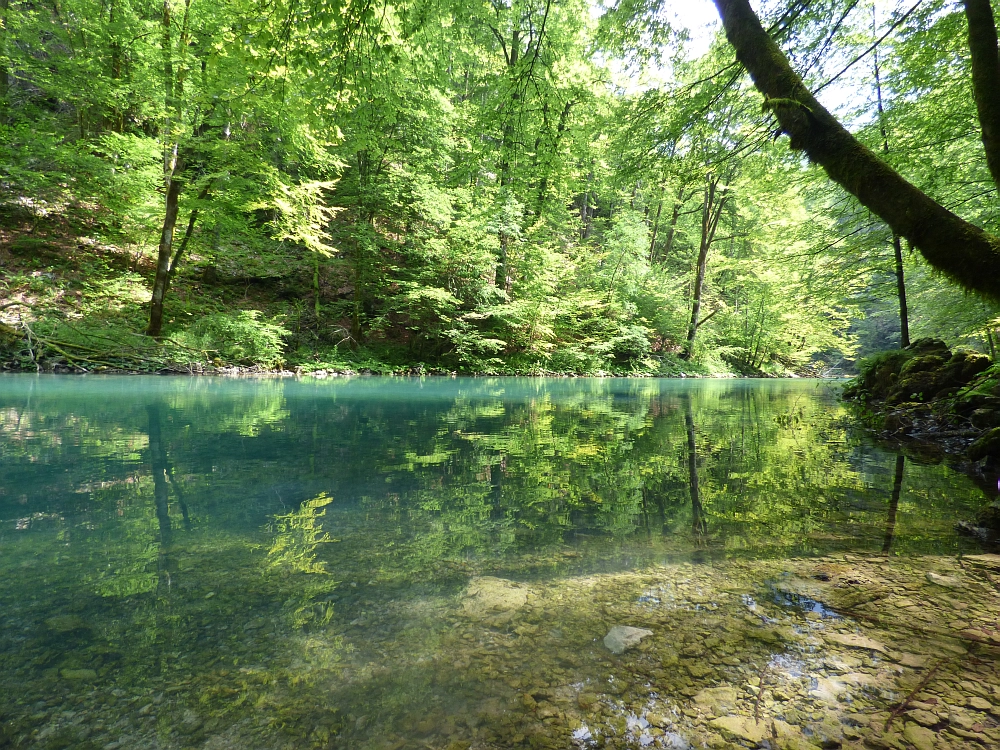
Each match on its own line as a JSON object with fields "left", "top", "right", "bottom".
{"left": 0, "top": 206, "right": 734, "bottom": 377}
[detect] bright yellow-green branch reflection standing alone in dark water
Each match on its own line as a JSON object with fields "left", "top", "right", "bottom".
{"left": 267, "top": 493, "right": 337, "bottom": 627}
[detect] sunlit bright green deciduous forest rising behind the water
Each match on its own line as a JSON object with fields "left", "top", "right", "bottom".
{"left": 0, "top": 0, "right": 1000, "bottom": 376}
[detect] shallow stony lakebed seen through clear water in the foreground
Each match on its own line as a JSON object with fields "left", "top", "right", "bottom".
{"left": 0, "top": 554, "right": 1000, "bottom": 750}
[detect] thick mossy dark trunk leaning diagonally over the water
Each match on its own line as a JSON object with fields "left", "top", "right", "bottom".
{"left": 714, "top": 0, "right": 1000, "bottom": 300}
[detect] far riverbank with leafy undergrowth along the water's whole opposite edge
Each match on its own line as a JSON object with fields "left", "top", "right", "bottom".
{"left": 0, "top": 202, "right": 839, "bottom": 377}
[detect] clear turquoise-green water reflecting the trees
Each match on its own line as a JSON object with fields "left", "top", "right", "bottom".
{"left": 0, "top": 375, "right": 1000, "bottom": 750}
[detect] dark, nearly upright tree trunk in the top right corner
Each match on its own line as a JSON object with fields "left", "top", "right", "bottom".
{"left": 965, "top": 0, "right": 1000, "bottom": 192}
